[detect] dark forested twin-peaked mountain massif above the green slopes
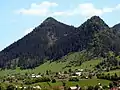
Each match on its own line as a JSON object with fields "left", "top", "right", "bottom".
{"left": 0, "top": 16, "right": 120, "bottom": 68}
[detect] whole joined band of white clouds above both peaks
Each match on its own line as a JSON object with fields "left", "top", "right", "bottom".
{"left": 17, "top": 1, "right": 120, "bottom": 17}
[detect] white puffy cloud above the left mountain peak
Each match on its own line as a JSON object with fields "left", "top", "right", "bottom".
{"left": 16, "top": 1, "right": 58, "bottom": 16}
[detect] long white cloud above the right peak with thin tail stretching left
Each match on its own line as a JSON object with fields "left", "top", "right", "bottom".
{"left": 52, "top": 3, "right": 120, "bottom": 18}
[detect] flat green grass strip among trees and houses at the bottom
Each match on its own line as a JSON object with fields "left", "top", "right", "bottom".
{"left": 32, "top": 79, "right": 111, "bottom": 87}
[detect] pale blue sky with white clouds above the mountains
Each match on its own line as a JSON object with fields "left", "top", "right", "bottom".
{"left": 0, "top": 0, "right": 120, "bottom": 51}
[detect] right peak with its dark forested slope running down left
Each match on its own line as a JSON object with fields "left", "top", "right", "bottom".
{"left": 44, "top": 16, "right": 109, "bottom": 60}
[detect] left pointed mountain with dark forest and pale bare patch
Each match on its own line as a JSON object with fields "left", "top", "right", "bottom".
{"left": 0, "top": 17, "right": 75, "bottom": 68}
